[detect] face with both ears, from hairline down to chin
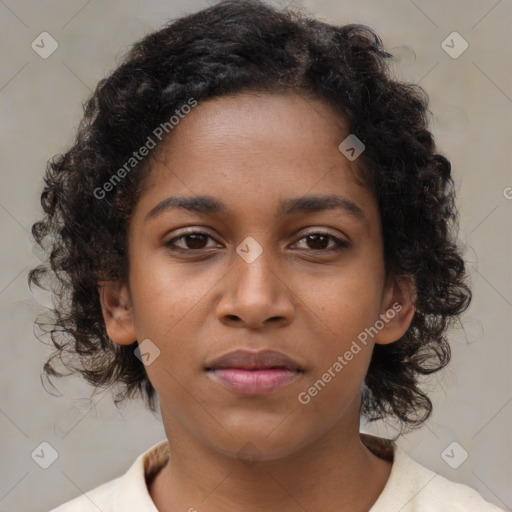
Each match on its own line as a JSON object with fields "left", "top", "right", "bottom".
{"left": 102, "top": 93, "right": 411, "bottom": 460}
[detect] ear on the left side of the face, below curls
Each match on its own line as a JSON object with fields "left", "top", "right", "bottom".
{"left": 98, "top": 281, "right": 137, "bottom": 345}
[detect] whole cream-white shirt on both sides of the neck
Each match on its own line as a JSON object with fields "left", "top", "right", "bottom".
{"left": 50, "top": 434, "right": 504, "bottom": 512}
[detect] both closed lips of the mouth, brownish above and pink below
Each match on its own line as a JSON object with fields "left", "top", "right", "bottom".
{"left": 205, "top": 349, "right": 304, "bottom": 396}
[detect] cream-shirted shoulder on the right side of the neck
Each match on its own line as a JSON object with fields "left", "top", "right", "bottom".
{"left": 370, "top": 438, "right": 503, "bottom": 512}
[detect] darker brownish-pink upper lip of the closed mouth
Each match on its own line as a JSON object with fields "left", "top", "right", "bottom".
{"left": 206, "top": 349, "right": 303, "bottom": 371}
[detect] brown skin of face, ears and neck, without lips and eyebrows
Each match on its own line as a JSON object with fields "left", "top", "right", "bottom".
{"left": 100, "top": 93, "right": 414, "bottom": 512}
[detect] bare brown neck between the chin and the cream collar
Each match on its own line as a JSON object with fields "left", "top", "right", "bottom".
{"left": 149, "top": 410, "right": 391, "bottom": 512}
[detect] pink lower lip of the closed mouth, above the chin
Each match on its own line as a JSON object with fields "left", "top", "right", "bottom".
{"left": 210, "top": 368, "right": 300, "bottom": 396}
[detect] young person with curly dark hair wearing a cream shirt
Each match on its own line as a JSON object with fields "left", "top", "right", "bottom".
{"left": 31, "top": 0, "right": 499, "bottom": 512}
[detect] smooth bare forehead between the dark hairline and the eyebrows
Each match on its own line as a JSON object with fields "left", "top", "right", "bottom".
{"left": 136, "top": 93, "right": 372, "bottom": 226}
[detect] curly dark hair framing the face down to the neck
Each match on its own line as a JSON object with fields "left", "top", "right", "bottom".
{"left": 28, "top": 0, "right": 471, "bottom": 428}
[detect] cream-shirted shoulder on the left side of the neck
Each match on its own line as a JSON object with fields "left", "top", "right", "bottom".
{"left": 50, "top": 439, "right": 169, "bottom": 512}
